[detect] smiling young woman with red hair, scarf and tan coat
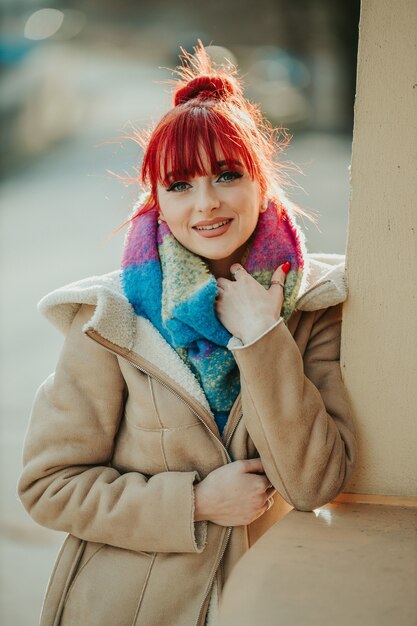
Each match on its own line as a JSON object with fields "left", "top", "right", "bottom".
{"left": 19, "top": 46, "right": 355, "bottom": 626}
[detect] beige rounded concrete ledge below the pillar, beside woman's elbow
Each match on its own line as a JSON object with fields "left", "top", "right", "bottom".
{"left": 219, "top": 502, "right": 417, "bottom": 626}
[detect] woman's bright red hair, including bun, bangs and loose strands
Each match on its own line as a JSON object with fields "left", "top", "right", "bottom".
{"left": 127, "top": 42, "right": 302, "bottom": 219}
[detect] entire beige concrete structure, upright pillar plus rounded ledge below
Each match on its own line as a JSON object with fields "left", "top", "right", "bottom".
{"left": 219, "top": 6, "right": 417, "bottom": 626}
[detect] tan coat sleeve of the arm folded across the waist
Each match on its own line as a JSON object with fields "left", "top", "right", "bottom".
{"left": 18, "top": 306, "right": 206, "bottom": 552}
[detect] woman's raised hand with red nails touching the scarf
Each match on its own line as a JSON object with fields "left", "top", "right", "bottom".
{"left": 216, "top": 262, "right": 289, "bottom": 343}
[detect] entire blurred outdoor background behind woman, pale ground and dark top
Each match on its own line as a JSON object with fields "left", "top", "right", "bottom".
{"left": 0, "top": 0, "right": 359, "bottom": 626}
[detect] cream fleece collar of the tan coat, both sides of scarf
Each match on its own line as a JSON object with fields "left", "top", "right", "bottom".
{"left": 39, "top": 255, "right": 347, "bottom": 414}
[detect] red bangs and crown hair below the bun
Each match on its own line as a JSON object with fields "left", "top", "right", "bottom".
{"left": 142, "top": 103, "right": 260, "bottom": 189}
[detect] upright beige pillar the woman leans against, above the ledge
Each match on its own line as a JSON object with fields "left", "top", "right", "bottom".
{"left": 342, "top": 0, "right": 417, "bottom": 496}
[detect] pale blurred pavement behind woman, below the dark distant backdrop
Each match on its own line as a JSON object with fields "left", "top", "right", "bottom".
{"left": 0, "top": 59, "right": 351, "bottom": 626}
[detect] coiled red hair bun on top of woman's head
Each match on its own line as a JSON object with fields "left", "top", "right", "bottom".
{"left": 174, "top": 76, "right": 240, "bottom": 106}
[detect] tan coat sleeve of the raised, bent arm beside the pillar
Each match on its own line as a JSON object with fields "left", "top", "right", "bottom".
{"left": 232, "top": 305, "right": 356, "bottom": 511}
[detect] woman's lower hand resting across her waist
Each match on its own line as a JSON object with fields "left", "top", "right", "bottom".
{"left": 194, "top": 458, "right": 276, "bottom": 526}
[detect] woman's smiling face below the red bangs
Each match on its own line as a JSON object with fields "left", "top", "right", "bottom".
{"left": 158, "top": 154, "right": 261, "bottom": 266}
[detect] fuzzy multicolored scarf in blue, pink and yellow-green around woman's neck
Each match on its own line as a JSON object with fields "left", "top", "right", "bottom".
{"left": 122, "top": 201, "right": 304, "bottom": 431}
